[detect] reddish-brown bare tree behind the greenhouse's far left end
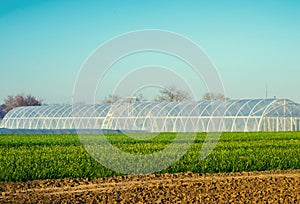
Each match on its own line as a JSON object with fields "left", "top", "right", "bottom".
{"left": 4, "top": 94, "right": 42, "bottom": 113}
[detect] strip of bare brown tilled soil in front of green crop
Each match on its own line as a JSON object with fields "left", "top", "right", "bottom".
{"left": 0, "top": 170, "right": 300, "bottom": 203}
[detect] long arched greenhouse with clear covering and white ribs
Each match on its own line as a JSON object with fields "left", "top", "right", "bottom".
{"left": 0, "top": 99, "right": 300, "bottom": 132}
